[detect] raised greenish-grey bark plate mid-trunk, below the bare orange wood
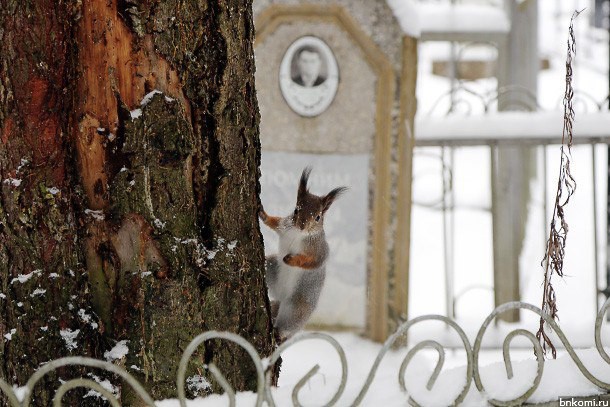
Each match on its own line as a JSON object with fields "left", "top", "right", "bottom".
{"left": 108, "top": 92, "right": 205, "bottom": 397}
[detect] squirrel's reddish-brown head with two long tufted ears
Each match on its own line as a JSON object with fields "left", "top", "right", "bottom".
{"left": 292, "top": 167, "right": 347, "bottom": 232}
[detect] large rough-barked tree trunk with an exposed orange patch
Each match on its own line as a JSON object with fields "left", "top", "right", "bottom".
{"left": 0, "top": 0, "right": 274, "bottom": 405}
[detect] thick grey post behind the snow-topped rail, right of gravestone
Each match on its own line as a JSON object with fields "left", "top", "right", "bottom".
{"left": 491, "top": 0, "right": 539, "bottom": 321}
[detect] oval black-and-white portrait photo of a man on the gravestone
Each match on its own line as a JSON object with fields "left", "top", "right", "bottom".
{"left": 279, "top": 35, "right": 339, "bottom": 117}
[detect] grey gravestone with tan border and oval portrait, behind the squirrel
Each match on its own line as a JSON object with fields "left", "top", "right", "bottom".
{"left": 249, "top": 0, "right": 417, "bottom": 340}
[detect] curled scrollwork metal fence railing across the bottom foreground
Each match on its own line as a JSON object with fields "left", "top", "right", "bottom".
{"left": 0, "top": 300, "right": 610, "bottom": 407}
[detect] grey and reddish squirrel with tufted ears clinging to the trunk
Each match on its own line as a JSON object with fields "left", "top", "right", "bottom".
{"left": 259, "top": 167, "right": 347, "bottom": 339}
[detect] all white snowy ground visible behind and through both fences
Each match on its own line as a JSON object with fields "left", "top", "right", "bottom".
{"left": 158, "top": 0, "right": 610, "bottom": 407}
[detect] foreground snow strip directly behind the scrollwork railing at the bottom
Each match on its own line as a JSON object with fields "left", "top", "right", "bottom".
{"left": 157, "top": 333, "right": 610, "bottom": 407}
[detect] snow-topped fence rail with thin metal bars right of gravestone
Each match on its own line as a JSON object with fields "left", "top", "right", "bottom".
{"left": 413, "top": 85, "right": 610, "bottom": 317}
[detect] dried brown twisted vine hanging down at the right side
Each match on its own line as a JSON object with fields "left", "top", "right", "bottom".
{"left": 536, "top": 10, "right": 582, "bottom": 359}
